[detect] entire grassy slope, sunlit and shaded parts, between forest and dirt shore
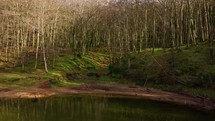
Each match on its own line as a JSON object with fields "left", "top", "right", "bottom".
{"left": 0, "top": 44, "right": 215, "bottom": 99}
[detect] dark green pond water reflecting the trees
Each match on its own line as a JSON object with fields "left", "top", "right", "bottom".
{"left": 0, "top": 96, "right": 215, "bottom": 121}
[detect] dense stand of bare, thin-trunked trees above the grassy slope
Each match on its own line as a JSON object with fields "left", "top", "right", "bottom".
{"left": 0, "top": 0, "right": 215, "bottom": 69}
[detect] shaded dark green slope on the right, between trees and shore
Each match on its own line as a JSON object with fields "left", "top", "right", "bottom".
{"left": 109, "top": 43, "right": 215, "bottom": 99}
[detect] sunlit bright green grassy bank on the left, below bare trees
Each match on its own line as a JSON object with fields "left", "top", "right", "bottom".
{"left": 0, "top": 52, "right": 109, "bottom": 88}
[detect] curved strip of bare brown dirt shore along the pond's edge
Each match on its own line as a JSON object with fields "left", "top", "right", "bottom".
{"left": 0, "top": 83, "right": 215, "bottom": 110}
